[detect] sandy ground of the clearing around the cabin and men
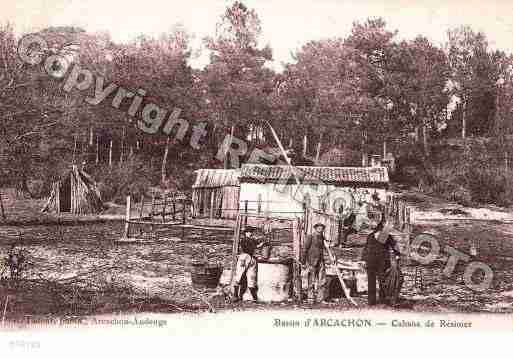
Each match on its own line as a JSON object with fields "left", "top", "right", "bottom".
{"left": 0, "top": 188, "right": 513, "bottom": 318}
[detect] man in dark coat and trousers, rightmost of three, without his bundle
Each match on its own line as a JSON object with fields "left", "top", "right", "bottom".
{"left": 362, "top": 218, "right": 400, "bottom": 305}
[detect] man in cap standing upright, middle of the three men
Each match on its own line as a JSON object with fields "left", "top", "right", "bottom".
{"left": 301, "top": 223, "right": 326, "bottom": 303}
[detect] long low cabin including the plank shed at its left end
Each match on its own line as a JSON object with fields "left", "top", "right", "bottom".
{"left": 192, "top": 164, "right": 389, "bottom": 219}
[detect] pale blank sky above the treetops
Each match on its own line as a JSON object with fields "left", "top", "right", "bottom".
{"left": 0, "top": 0, "right": 513, "bottom": 70}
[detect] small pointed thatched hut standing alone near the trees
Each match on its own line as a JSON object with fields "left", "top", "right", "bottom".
{"left": 42, "top": 166, "right": 103, "bottom": 214}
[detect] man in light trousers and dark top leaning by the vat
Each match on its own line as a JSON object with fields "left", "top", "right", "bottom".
{"left": 233, "top": 227, "right": 264, "bottom": 302}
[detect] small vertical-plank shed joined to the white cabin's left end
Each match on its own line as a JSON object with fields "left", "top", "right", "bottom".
{"left": 192, "top": 169, "right": 240, "bottom": 219}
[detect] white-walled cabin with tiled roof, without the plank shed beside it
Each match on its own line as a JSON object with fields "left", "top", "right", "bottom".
{"left": 239, "top": 164, "right": 389, "bottom": 218}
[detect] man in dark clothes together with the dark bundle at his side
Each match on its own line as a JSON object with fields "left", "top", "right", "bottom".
{"left": 362, "top": 216, "right": 402, "bottom": 305}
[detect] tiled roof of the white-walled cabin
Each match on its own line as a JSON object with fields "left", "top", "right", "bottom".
{"left": 240, "top": 164, "right": 389, "bottom": 185}
